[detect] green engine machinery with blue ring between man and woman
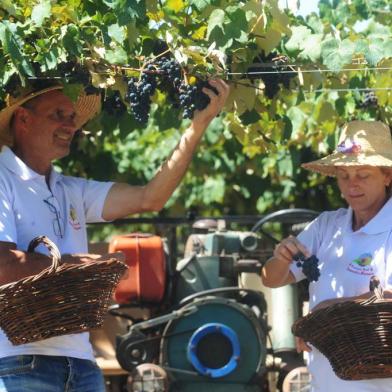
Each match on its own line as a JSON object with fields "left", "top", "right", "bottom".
{"left": 111, "top": 210, "right": 317, "bottom": 392}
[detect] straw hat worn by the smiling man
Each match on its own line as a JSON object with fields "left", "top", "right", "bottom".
{"left": 0, "top": 85, "right": 101, "bottom": 146}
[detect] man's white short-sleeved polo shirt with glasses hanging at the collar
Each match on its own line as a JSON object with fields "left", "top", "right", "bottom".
{"left": 0, "top": 147, "right": 113, "bottom": 360}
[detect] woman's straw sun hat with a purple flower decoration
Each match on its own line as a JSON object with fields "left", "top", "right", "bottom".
{"left": 301, "top": 121, "right": 392, "bottom": 176}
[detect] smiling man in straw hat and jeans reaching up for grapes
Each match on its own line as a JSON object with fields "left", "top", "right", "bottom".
{"left": 0, "top": 80, "right": 229, "bottom": 392}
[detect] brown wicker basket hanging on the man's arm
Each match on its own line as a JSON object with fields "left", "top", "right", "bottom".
{"left": 0, "top": 236, "right": 127, "bottom": 345}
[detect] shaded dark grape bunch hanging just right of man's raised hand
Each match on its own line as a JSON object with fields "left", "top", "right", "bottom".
{"left": 247, "top": 52, "right": 297, "bottom": 99}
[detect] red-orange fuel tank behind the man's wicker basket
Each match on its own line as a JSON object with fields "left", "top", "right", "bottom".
{"left": 109, "top": 233, "right": 166, "bottom": 304}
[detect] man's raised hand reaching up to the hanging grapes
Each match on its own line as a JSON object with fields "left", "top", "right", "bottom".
{"left": 192, "top": 79, "right": 230, "bottom": 128}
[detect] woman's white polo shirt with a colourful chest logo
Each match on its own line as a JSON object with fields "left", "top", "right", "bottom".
{"left": 290, "top": 199, "right": 392, "bottom": 392}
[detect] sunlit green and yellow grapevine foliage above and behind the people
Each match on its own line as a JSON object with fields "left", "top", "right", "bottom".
{"left": 0, "top": 0, "right": 392, "bottom": 215}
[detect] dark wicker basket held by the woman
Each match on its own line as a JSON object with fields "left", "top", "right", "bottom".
{"left": 292, "top": 277, "right": 392, "bottom": 380}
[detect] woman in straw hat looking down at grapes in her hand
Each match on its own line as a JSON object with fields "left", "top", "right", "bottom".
{"left": 262, "top": 121, "right": 392, "bottom": 392}
